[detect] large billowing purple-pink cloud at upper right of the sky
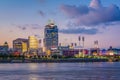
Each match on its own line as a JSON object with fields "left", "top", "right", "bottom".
{"left": 60, "top": 0, "right": 120, "bottom": 26}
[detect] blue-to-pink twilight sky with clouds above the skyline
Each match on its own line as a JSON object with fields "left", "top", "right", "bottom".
{"left": 0, "top": 0, "right": 120, "bottom": 48}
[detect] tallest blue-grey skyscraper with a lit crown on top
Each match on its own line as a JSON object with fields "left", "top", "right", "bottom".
{"left": 44, "top": 21, "right": 58, "bottom": 50}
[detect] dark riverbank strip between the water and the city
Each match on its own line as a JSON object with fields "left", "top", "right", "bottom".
{"left": 0, "top": 58, "right": 109, "bottom": 63}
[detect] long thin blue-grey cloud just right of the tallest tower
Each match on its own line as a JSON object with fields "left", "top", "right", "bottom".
{"left": 59, "top": 28, "right": 98, "bottom": 35}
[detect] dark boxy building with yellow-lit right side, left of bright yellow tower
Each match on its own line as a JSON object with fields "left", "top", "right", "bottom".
{"left": 13, "top": 38, "right": 28, "bottom": 53}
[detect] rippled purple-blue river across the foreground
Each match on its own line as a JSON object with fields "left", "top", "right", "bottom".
{"left": 0, "top": 62, "right": 120, "bottom": 80}
